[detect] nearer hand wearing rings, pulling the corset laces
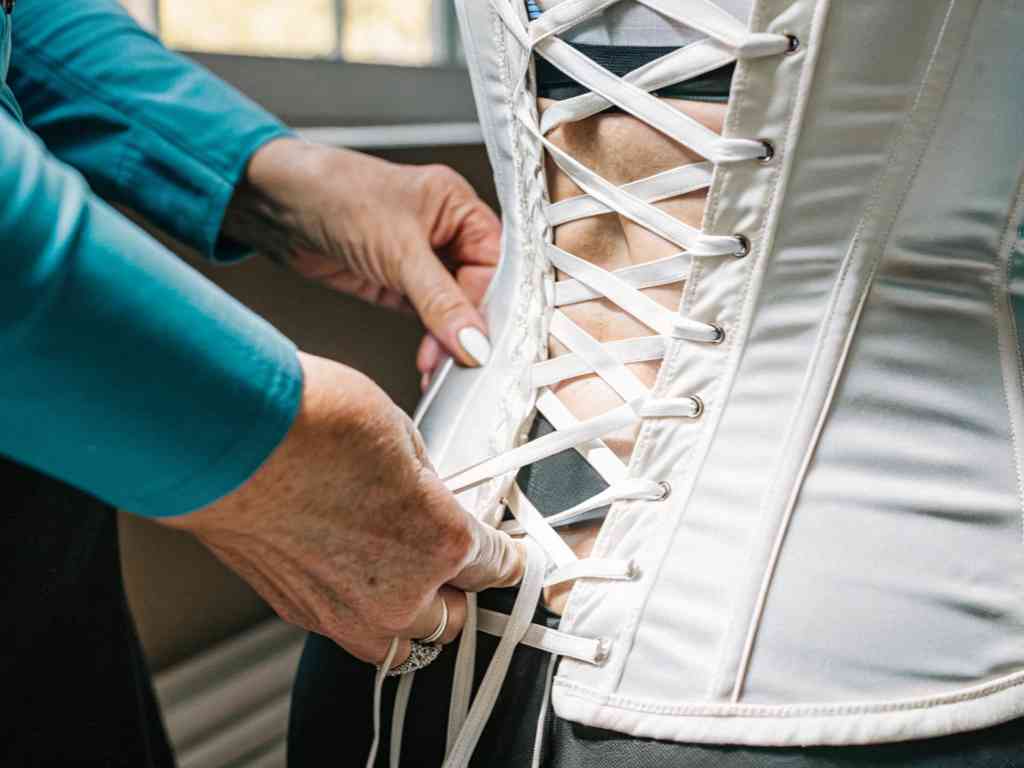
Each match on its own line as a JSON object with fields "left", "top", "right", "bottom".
{"left": 162, "top": 355, "right": 523, "bottom": 665}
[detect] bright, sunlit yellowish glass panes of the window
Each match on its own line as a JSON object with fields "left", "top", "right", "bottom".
{"left": 116, "top": 0, "right": 458, "bottom": 66}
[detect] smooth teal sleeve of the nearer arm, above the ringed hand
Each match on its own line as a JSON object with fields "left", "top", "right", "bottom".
{"left": 0, "top": 111, "right": 302, "bottom": 515}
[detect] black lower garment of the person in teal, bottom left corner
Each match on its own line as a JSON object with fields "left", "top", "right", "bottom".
{"left": 0, "top": 459, "right": 174, "bottom": 768}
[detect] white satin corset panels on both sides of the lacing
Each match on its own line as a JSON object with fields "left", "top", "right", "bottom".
{"left": 419, "top": 0, "right": 1024, "bottom": 745}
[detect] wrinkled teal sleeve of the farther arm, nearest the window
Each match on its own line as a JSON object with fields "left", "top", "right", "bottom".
{"left": 8, "top": 0, "right": 288, "bottom": 261}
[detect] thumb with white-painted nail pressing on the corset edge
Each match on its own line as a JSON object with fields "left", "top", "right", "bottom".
{"left": 401, "top": 244, "right": 490, "bottom": 368}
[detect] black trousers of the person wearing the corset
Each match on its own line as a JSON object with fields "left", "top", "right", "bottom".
{"left": 288, "top": 590, "right": 1024, "bottom": 768}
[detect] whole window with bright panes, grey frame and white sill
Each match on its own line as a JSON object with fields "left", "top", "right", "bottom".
{"left": 121, "top": 0, "right": 481, "bottom": 143}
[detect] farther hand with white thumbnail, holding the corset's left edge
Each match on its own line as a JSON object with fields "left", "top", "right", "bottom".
{"left": 224, "top": 138, "right": 501, "bottom": 391}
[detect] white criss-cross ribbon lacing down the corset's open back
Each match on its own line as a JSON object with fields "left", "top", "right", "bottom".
{"left": 370, "top": 0, "right": 798, "bottom": 768}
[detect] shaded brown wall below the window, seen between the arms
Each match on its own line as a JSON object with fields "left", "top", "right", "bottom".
{"left": 121, "top": 146, "right": 495, "bottom": 670}
